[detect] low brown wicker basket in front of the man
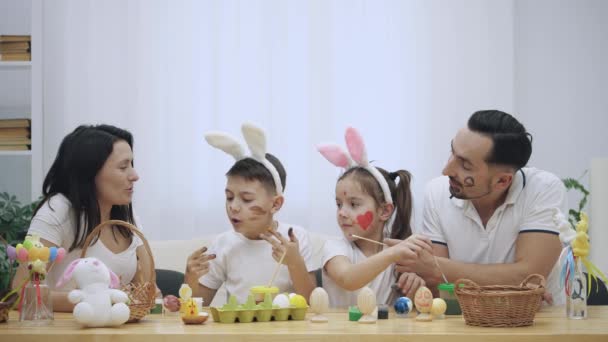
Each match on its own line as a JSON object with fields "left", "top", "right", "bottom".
{"left": 454, "top": 274, "right": 545, "bottom": 327}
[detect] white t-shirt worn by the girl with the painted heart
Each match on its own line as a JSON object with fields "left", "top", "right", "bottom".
{"left": 322, "top": 237, "right": 397, "bottom": 308}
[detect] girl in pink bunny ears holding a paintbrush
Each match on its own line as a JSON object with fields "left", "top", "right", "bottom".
{"left": 319, "top": 128, "right": 432, "bottom": 308}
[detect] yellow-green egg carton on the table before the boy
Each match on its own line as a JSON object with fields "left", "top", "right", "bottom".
{"left": 210, "top": 294, "right": 308, "bottom": 323}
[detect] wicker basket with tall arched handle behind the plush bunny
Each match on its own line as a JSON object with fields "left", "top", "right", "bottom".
{"left": 80, "top": 220, "right": 156, "bottom": 323}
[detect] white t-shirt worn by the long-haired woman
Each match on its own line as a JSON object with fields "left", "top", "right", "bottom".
{"left": 28, "top": 194, "right": 142, "bottom": 291}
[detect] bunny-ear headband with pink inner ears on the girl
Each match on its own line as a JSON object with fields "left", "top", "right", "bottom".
{"left": 317, "top": 127, "right": 393, "bottom": 204}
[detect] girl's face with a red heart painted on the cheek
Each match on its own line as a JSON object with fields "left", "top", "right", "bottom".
{"left": 336, "top": 177, "right": 385, "bottom": 241}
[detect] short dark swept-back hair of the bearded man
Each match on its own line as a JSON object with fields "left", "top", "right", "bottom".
{"left": 468, "top": 110, "right": 532, "bottom": 170}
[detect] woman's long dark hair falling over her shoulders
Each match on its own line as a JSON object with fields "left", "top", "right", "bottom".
{"left": 34, "top": 125, "right": 135, "bottom": 251}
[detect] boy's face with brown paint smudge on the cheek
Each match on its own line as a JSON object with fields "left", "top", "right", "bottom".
{"left": 226, "top": 176, "right": 283, "bottom": 240}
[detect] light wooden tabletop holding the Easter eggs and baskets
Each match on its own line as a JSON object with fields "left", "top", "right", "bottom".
{"left": 0, "top": 306, "right": 608, "bottom": 342}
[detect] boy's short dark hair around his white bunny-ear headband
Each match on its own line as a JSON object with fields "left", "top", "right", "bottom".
{"left": 226, "top": 153, "right": 287, "bottom": 195}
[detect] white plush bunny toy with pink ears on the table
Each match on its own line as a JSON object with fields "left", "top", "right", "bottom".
{"left": 57, "top": 258, "right": 130, "bottom": 327}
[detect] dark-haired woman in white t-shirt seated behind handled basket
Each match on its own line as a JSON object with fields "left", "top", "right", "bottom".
{"left": 13, "top": 125, "right": 150, "bottom": 312}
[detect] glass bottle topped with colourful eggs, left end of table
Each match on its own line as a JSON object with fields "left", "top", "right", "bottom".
{"left": 1, "top": 235, "right": 65, "bottom": 324}
